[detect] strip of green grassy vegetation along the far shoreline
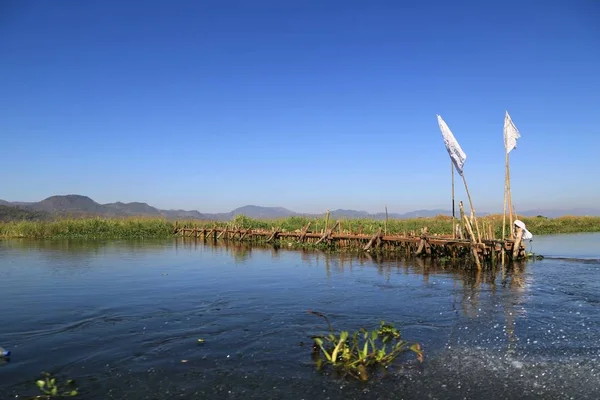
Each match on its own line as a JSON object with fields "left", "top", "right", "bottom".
{"left": 0, "top": 215, "right": 600, "bottom": 239}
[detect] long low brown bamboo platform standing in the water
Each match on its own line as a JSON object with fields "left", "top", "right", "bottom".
{"left": 174, "top": 222, "right": 526, "bottom": 269}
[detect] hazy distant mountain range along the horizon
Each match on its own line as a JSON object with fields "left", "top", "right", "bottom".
{"left": 0, "top": 194, "right": 600, "bottom": 221}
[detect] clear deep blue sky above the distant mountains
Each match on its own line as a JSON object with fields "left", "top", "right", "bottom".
{"left": 0, "top": 0, "right": 600, "bottom": 212}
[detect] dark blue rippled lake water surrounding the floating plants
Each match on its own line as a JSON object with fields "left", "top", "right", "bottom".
{"left": 0, "top": 234, "right": 600, "bottom": 399}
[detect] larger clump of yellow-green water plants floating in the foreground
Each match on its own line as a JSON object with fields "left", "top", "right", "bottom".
{"left": 308, "top": 310, "right": 423, "bottom": 381}
